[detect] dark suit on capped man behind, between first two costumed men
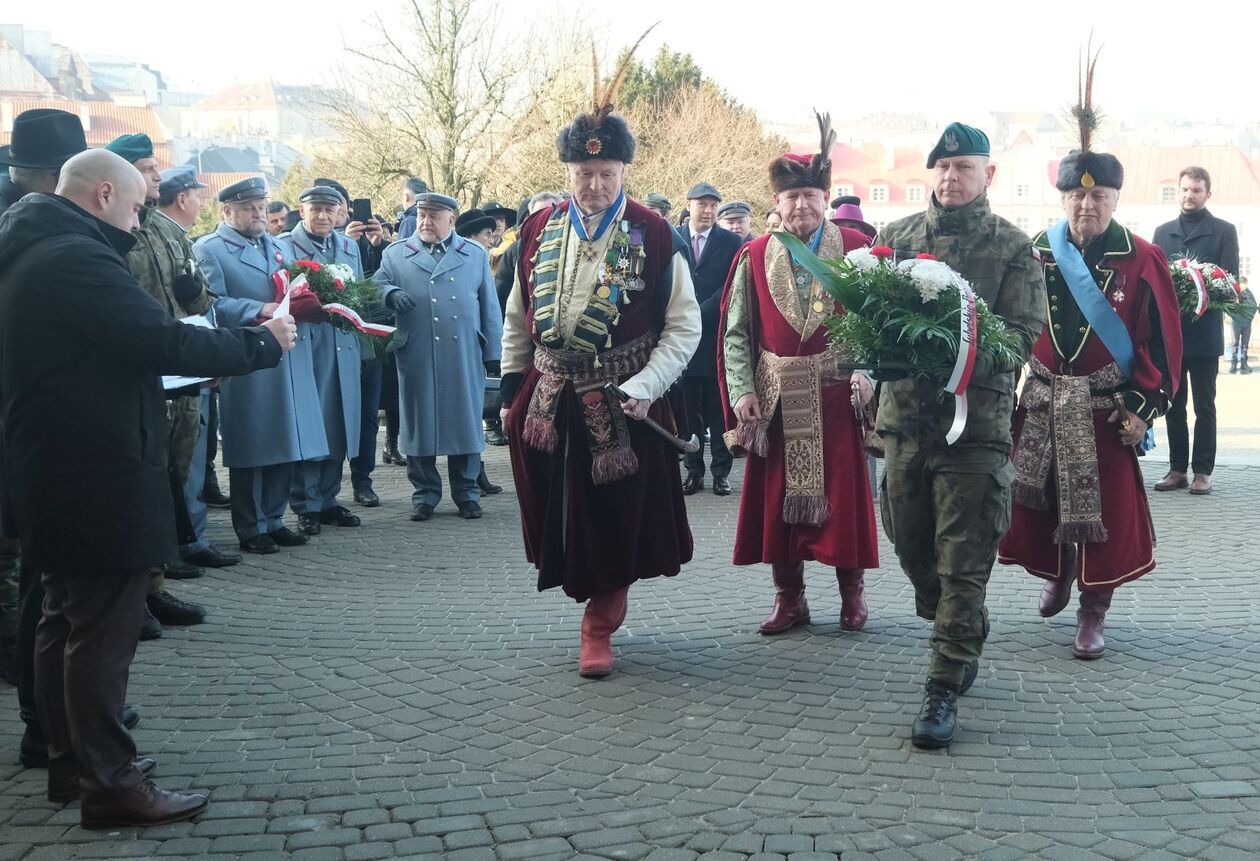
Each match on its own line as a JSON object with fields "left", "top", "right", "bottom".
{"left": 679, "top": 224, "right": 743, "bottom": 479}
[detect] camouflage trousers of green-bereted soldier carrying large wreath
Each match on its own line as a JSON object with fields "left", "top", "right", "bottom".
{"left": 879, "top": 435, "right": 1014, "bottom": 685}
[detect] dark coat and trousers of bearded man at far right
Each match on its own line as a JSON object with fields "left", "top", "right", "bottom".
{"left": 1154, "top": 209, "right": 1239, "bottom": 475}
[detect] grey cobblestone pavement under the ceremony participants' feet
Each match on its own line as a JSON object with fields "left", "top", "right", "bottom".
{"left": 0, "top": 400, "right": 1260, "bottom": 861}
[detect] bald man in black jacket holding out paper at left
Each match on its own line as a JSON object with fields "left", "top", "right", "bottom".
{"left": 0, "top": 150, "right": 296, "bottom": 828}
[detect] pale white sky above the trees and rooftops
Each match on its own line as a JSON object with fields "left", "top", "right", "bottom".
{"left": 12, "top": 0, "right": 1260, "bottom": 124}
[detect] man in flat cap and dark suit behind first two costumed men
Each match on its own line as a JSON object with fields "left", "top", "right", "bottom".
{"left": 678, "top": 183, "right": 743, "bottom": 497}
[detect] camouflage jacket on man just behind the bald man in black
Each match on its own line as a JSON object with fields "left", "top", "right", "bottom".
{"left": 127, "top": 208, "right": 214, "bottom": 318}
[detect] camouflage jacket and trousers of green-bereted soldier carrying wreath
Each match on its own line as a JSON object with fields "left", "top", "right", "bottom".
{"left": 876, "top": 194, "right": 1046, "bottom": 686}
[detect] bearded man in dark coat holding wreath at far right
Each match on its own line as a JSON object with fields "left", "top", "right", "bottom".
{"left": 1154, "top": 166, "right": 1239, "bottom": 495}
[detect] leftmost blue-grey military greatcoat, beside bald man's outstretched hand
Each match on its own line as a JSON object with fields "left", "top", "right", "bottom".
{"left": 193, "top": 224, "right": 329, "bottom": 468}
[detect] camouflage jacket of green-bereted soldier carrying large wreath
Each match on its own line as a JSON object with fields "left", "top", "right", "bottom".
{"left": 876, "top": 194, "right": 1046, "bottom": 450}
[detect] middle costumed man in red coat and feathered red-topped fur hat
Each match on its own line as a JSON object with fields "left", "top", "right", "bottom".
{"left": 718, "top": 117, "right": 879, "bottom": 634}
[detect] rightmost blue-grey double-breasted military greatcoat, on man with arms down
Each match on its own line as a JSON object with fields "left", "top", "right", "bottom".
{"left": 373, "top": 234, "right": 503, "bottom": 458}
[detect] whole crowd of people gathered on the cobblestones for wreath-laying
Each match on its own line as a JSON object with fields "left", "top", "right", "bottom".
{"left": 0, "top": 57, "right": 1255, "bottom": 828}
